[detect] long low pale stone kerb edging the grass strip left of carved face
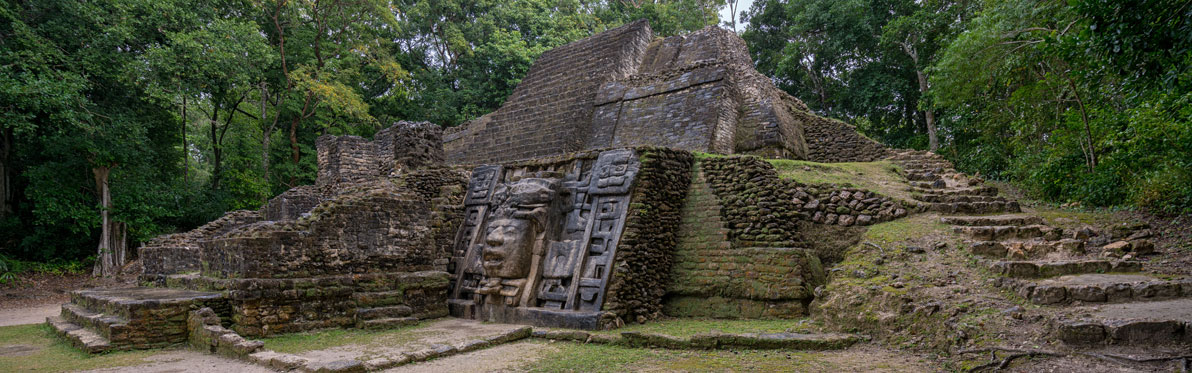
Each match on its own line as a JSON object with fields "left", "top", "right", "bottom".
{"left": 248, "top": 327, "right": 532, "bottom": 373}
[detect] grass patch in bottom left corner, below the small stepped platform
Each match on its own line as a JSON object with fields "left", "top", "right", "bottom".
{"left": 0, "top": 324, "right": 157, "bottom": 372}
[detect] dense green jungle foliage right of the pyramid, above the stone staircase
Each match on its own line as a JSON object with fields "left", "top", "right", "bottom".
{"left": 743, "top": 0, "right": 1192, "bottom": 213}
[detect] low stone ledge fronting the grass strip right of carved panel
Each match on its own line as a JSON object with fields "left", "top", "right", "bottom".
{"left": 533, "top": 330, "right": 865, "bottom": 350}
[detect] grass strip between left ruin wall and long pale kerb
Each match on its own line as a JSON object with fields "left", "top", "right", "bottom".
{"left": 262, "top": 324, "right": 434, "bottom": 354}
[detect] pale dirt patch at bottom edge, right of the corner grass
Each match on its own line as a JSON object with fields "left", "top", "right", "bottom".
{"left": 78, "top": 349, "right": 273, "bottom": 373}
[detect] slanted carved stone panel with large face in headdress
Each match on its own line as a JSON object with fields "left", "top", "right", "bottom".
{"left": 452, "top": 149, "right": 639, "bottom": 325}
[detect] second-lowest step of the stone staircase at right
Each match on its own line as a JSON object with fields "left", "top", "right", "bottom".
{"left": 1002, "top": 274, "right": 1192, "bottom": 305}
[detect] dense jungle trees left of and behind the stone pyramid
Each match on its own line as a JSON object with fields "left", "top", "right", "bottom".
{"left": 0, "top": 0, "right": 721, "bottom": 265}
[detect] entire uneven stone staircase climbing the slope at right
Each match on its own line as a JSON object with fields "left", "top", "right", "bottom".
{"left": 890, "top": 151, "right": 1192, "bottom": 348}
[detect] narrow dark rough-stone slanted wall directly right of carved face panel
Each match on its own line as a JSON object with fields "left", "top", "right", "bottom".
{"left": 603, "top": 148, "right": 695, "bottom": 323}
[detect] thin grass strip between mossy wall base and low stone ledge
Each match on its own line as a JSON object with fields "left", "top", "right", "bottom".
{"left": 586, "top": 318, "right": 815, "bottom": 338}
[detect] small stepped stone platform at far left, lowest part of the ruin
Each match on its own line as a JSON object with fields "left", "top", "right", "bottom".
{"left": 46, "top": 287, "right": 230, "bottom": 353}
